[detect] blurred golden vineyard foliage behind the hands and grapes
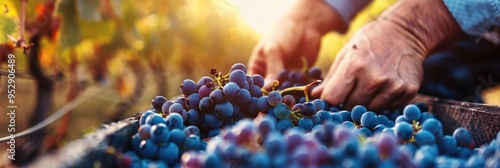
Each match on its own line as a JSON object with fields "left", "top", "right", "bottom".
{"left": 0, "top": 0, "right": 500, "bottom": 163}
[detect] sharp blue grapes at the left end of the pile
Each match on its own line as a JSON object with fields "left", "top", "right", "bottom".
{"left": 125, "top": 111, "right": 207, "bottom": 167}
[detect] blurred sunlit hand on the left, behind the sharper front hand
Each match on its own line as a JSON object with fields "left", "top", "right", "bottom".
{"left": 248, "top": 0, "right": 345, "bottom": 87}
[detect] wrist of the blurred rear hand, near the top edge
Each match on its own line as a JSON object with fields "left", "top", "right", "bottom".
{"left": 287, "top": 0, "right": 347, "bottom": 35}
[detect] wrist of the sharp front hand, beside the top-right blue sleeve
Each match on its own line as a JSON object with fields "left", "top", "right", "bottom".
{"left": 379, "top": 0, "right": 464, "bottom": 57}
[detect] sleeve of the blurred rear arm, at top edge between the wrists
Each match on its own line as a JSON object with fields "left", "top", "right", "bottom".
{"left": 326, "top": 0, "right": 371, "bottom": 25}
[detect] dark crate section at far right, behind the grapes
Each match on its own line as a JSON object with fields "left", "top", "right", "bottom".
{"left": 414, "top": 95, "right": 500, "bottom": 147}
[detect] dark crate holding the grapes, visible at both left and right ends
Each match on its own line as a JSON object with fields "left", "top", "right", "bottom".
{"left": 29, "top": 95, "right": 500, "bottom": 167}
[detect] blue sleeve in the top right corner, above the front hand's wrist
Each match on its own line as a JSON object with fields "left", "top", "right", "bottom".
{"left": 443, "top": 0, "right": 500, "bottom": 37}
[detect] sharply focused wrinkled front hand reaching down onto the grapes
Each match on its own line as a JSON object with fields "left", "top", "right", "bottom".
{"left": 312, "top": 0, "right": 460, "bottom": 110}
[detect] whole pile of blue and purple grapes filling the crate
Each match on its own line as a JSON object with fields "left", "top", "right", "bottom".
{"left": 118, "top": 64, "right": 500, "bottom": 168}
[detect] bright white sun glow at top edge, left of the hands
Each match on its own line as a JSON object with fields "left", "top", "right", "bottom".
{"left": 233, "top": 0, "right": 294, "bottom": 34}
